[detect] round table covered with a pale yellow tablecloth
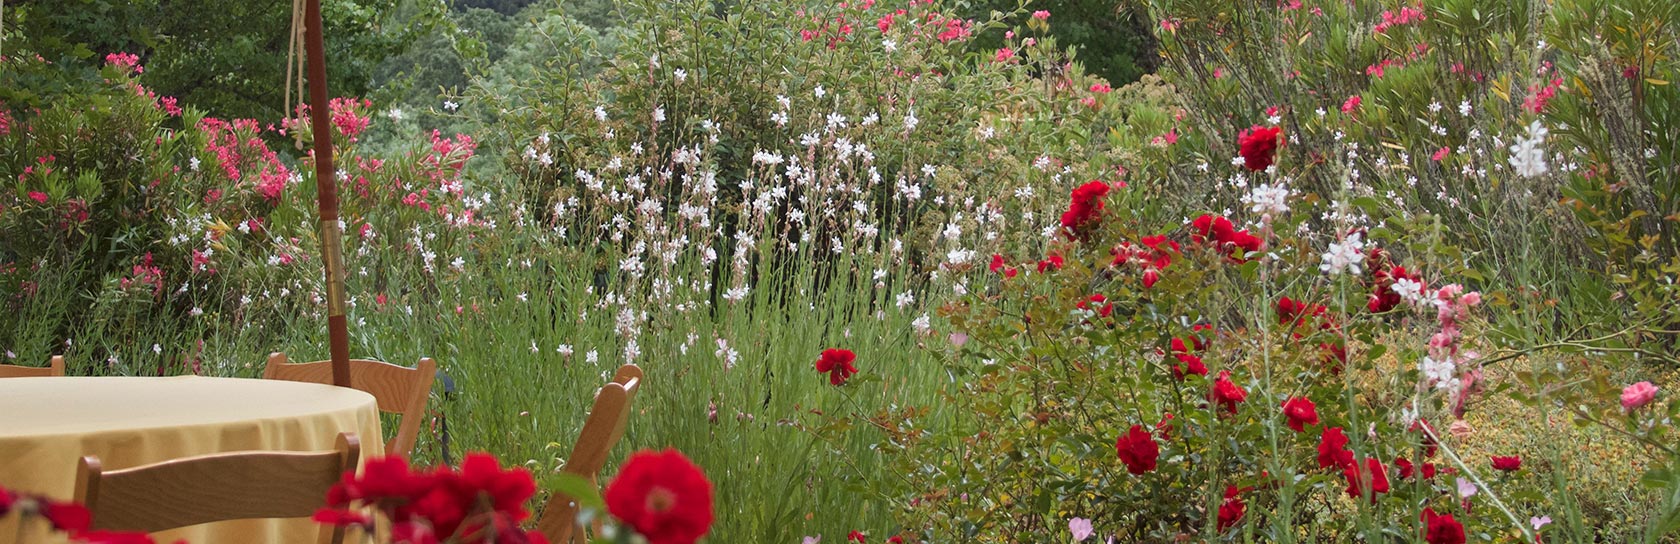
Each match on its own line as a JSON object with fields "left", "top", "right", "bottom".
{"left": 0, "top": 376, "right": 385, "bottom": 544}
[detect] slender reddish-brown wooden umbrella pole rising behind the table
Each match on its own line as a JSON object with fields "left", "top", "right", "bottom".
{"left": 294, "top": 0, "right": 349, "bottom": 388}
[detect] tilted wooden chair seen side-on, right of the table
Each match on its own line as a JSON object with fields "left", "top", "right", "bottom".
{"left": 536, "top": 364, "right": 642, "bottom": 544}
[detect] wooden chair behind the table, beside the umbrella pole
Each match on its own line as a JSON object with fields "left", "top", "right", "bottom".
{"left": 262, "top": 353, "right": 437, "bottom": 457}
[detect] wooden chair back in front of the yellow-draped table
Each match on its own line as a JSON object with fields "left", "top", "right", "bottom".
{"left": 76, "top": 433, "right": 361, "bottom": 544}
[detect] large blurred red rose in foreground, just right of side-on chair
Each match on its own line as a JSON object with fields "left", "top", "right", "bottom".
{"left": 605, "top": 448, "right": 712, "bottom": 544}
